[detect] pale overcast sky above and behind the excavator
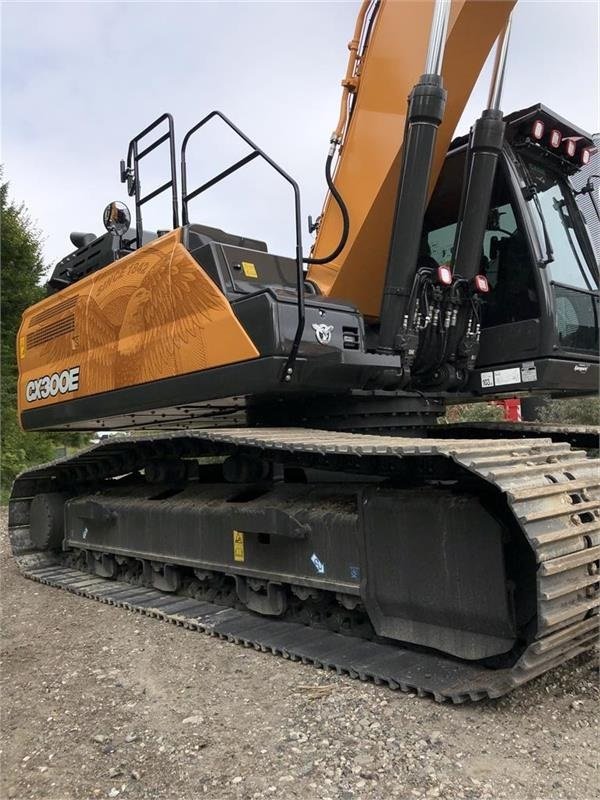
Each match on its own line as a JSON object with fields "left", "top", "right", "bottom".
{"left": 2, "top": 0, "right": 600, "bottom": 274}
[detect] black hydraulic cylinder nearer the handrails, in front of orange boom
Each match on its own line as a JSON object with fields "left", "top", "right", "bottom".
{"left": 379, "top": 74, "right": 446, "bottom": 352}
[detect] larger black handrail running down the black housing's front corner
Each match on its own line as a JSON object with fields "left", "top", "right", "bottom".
{"left": 181, "top": 110, "right": 305, "bottom": 382}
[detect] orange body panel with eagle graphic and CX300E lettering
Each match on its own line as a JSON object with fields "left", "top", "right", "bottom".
{"left": 18, "top": 230, "right": 259, "bottom": 413}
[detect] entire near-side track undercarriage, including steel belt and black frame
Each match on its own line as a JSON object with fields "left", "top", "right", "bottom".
{"left": 10, "top": 426, "right": 600, "bottom": 702}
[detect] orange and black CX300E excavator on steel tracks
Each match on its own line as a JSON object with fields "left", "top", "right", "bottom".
{"left": 9, "top": 0, "right": 600, "bottom": 703}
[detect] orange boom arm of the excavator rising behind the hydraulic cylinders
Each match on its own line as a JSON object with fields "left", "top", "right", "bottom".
{"left": 308, "top": 0, "right": 516, "bottom": 317}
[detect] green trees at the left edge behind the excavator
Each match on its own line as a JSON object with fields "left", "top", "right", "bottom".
{"left": 0, "top": 176, "right": 83, "bottom": 497}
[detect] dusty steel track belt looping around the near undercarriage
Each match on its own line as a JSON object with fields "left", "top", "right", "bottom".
{"left": 9, "top": 428, "right": 600, "bottom": 703}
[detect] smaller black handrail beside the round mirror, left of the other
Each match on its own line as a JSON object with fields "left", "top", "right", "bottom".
{"left": 121, "top": 114, "right": 179, "bottom": 248}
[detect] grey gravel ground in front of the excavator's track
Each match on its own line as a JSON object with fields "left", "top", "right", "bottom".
{"left": 0, "top": 513, "right": 599, "bottom": 800}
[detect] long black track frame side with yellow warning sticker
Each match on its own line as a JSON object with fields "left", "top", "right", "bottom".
{"left": 65, "top": 483, "right": 359, "bottom": 595}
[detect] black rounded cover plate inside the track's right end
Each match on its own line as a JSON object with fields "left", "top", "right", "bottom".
{"left": 359, "top": 487, "right": 517, "bottom": 660}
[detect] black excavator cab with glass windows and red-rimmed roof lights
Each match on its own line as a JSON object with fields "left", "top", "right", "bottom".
{"left": 424, "top": 105, "right": 599, "bottom": 394}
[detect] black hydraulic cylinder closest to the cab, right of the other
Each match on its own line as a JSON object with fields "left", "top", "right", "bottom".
{"left": 453, "top": 109, "right": 506, "bottom": 280}
